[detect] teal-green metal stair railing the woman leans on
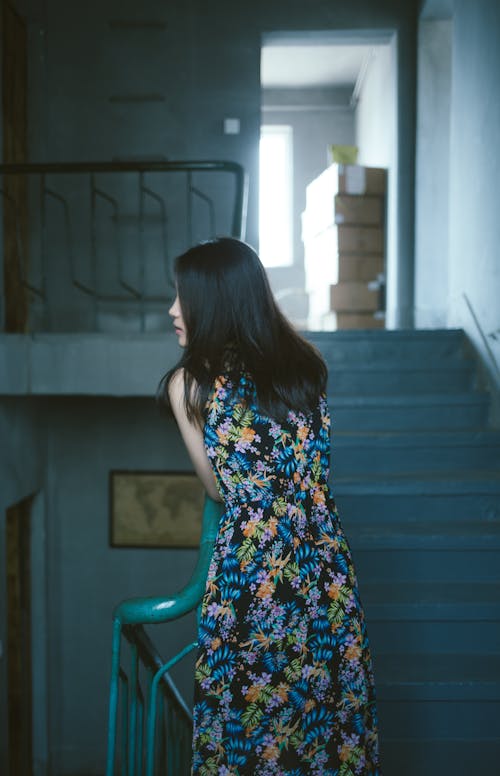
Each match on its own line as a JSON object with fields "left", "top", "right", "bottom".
{"left": 106, "top": 496, "right": 222, "bottom": 776}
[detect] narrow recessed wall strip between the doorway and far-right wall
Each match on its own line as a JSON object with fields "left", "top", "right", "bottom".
{"left": 415, "top": 19, "right": 452, "bottom": 328}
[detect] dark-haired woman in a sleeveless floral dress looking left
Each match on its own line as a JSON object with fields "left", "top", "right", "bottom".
{"left": 160, "top": 238, "right": 380, "bottom": 776}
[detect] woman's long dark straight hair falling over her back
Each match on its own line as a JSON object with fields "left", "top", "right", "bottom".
{"left": 158, "top": 237, "right": 327, "bottom": 421}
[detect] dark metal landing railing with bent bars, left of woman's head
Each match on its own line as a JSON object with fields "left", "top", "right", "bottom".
{"left": 0, "top": 161, "right": 247, "bottom": 331}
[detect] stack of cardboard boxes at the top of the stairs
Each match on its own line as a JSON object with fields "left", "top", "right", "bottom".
{"left": 303, "top": 165, "right": 386, "bottom": 328}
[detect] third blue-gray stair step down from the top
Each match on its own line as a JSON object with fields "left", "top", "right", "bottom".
{"left": 328, "top": 391, "right": 489, "bottom": 431}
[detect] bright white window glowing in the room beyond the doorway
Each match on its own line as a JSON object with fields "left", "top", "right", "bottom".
{"left": 259, "top": 124, "right": 293, "bottom": 267}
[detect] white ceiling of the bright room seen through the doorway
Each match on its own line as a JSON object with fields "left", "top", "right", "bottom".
{"left": 261, "top": 44, "right": 374, "bottom": 89}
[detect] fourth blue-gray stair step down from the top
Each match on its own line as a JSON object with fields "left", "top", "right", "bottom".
{"left": 332, "top": 430, "right": 500, "bottom": 477}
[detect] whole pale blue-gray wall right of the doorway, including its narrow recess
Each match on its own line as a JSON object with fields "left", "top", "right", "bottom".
{"left": 415, "top": 0, "right": 500, "bottom": 404}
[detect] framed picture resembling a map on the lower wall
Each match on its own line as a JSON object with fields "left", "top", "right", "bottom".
{"left": 109, "top": 471, "right": 205, "bottom": 547}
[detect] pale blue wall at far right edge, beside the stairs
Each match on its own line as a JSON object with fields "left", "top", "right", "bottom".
{"left": 448, "top": 0, "right": 500, "bottom": 410}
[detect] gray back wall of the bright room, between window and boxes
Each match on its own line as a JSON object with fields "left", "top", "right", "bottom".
{"left": 262, "top": 89, "right": 354, "bottom": 327}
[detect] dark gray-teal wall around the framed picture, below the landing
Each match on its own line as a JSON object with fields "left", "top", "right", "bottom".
{"left": 47, "top": 398, "right": 196, "bottom": 774}
